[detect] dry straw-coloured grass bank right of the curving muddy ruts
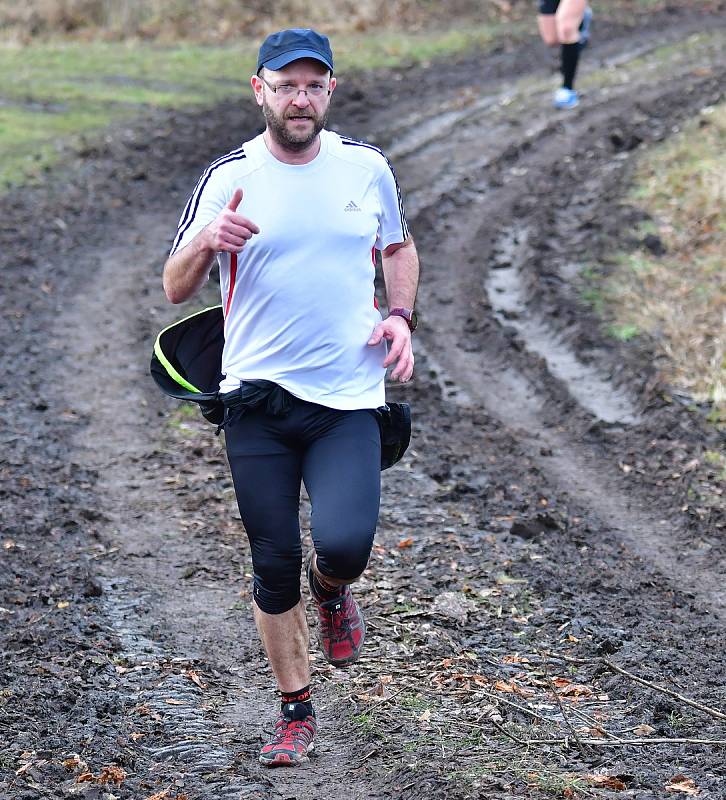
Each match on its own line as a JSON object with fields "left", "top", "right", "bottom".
{"left": 608, "top": 105, "right": 726, "bottom": 422}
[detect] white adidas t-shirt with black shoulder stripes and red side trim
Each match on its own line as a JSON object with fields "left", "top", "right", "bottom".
{"left": 171, "top": 130, "right": 408, "bottom": 409}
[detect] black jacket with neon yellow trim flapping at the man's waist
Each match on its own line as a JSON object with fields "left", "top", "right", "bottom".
{"left": 149, "top": 306, "right": 411, "bottom": 470}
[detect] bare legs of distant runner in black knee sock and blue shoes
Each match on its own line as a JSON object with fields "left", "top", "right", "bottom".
{"left": 537, "top": 0, "right": 592, "bottom": 108}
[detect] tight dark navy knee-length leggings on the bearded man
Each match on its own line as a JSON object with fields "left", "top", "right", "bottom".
{"left": 225, "top": 398, "right": 381, "bottom": 614}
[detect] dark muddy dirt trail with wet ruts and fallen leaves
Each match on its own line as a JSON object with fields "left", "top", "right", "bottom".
{"left": 0, "top": 4, "right": 726, "bottom": 800}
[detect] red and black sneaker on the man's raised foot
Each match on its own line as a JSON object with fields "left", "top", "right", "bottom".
{"left": 307, "top": 559, "right": 366, "bottom": 667}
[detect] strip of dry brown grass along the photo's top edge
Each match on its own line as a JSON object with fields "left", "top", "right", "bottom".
{"left": 0, "top": 0, "right": 528, "bottom": 42}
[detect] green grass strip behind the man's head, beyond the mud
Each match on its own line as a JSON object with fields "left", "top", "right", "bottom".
{"left": 0, "top": 25, "right": 512, "bottom": 187}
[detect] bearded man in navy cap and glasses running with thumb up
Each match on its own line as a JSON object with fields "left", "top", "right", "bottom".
{"left": 164, "top": 29, "right": 419, "bottom": 766}
